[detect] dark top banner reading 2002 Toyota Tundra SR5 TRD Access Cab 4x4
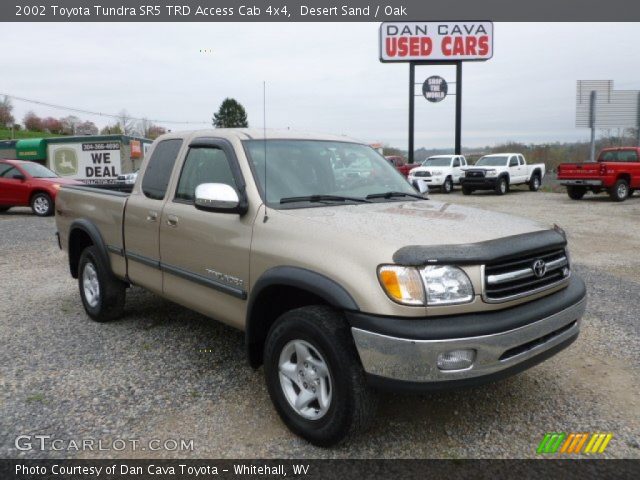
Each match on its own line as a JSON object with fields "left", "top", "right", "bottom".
{"left": 0, "top": 0, "right": 640, "bottom": 21}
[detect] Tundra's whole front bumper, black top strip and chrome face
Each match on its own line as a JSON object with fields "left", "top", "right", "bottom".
{"left": 348, "top": 275, "right": 587, "bottom": 390}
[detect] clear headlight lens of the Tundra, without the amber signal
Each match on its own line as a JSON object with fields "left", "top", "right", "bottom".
{"left": 420, "top": 265, "right": 473, "bottom": 305}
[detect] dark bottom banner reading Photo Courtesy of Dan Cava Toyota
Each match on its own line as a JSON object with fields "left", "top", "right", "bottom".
{"left": 0, "top": 459, "right": 640, "bottom": 480}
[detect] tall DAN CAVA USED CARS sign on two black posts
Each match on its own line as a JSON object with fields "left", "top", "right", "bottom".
{"left": 380, "top": 21, "right": 493, "bottom": 163}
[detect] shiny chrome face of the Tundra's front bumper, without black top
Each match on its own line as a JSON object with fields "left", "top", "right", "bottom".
{"left": 351, "top": 297, "right": 587, "bottom": 382}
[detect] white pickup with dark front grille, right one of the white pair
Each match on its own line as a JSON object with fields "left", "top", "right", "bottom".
{"left": 460, "top": 153, "right": 545, "bottom": 195}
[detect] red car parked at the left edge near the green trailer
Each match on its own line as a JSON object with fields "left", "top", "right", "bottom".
{"left": 0, "top": 160, "right": 82, "bottom": 217}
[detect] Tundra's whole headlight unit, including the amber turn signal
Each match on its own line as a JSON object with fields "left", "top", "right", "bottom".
{"left": 378, "top": 265, "right": 474, "bottom": 306}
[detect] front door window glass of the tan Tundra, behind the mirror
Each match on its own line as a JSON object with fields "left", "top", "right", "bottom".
{"left": 175, "top": 147, "right": 236, "bottom": 202}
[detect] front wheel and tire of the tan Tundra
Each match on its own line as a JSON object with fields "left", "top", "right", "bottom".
{"left": 264, "top": 306, "right": 377, "bottom": 447}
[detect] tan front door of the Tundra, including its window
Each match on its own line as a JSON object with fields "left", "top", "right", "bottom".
{"left": 160, "top": 138, "right": 253, "bottom": 327}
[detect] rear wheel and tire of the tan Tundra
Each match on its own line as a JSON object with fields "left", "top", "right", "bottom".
{"left": 78, "top": 245, "right": 126, "bottom": 322}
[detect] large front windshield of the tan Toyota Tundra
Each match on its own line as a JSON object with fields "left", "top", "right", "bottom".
{"left": 243, "top": 140, "right": 416, "bottom": 208}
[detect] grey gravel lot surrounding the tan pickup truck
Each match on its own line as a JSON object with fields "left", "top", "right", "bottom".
{"left": 0, "top": 190, "right": 640, "bottom": 458}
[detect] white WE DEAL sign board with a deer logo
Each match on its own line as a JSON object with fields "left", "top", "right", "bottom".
{"left": 47, "top": 142, "right": 121, "bottom": 183}
